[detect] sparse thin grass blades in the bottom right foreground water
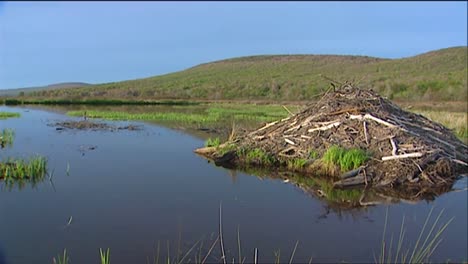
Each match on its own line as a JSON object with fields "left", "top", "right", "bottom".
{"left": 374, "top": 207, "right": 453, "bottom": 264}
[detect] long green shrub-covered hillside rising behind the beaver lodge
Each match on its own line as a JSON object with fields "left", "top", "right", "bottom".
{"left": 26, "top": 46, "right": 468, "bottom": 101}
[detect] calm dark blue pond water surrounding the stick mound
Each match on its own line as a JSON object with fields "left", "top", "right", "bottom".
{"left": 0, "top": 106, "right": 468, "bottom": 264}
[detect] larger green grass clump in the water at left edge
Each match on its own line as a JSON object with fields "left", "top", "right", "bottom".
{"left": 0, "top": 156, "right": 47, "bottom": 182}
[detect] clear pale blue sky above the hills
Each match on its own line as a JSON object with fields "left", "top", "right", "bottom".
{"left": 0, "top": 1, "right": 467, "bottom": 89}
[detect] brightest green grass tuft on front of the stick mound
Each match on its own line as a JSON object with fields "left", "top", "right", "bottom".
{"left": 322, "top": 145, "right": 369, "bottom": 172}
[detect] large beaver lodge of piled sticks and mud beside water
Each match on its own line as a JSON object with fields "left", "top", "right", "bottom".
{"left": 195, "top": 83, "right": 468, "bottom": 202}
